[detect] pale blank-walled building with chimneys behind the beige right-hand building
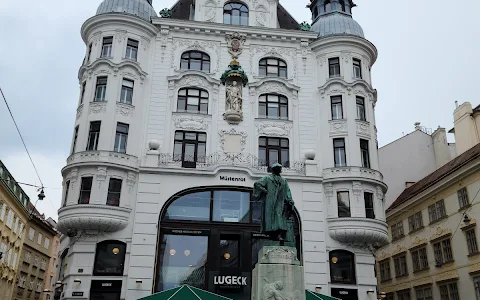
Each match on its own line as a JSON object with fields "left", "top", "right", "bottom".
{"left": 378, "top": 123, "right": 456, "bottom": 207}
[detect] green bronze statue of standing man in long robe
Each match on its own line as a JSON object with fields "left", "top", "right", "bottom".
{"left": 253, "top": 163, "right": 294, "bottom": 243}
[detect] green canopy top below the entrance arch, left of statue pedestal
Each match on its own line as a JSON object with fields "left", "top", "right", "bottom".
{"left": 139, "top": 285, "right": 232, "bottom": 300}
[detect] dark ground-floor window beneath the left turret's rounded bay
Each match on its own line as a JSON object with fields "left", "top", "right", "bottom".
{"left": 93, "top": 241, "right": 127, "bottom": 276}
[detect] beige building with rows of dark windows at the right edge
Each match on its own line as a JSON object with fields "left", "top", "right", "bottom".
{"left": 376, "top": 144, "right": 480, "bottom": 300}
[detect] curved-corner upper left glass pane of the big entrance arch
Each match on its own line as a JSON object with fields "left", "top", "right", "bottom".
{"left": 165, "top": 192, "right": 210, "bottom": 221}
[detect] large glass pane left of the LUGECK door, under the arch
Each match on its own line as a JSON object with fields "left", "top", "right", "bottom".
{"left": 156, "top": 234, "right": 208, "bottom": 291}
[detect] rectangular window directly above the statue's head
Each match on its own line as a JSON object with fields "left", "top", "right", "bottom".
{"left": 258, "top": 137, "right": 290, "bottom": 168}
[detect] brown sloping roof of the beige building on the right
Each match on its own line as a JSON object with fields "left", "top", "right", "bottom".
{"left": 387, "top": 144, "right": 480, "bottom": 213}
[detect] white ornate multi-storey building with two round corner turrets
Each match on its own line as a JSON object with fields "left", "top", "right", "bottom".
{"left": 55, "top": 0, "right": 387, "bottom": 300}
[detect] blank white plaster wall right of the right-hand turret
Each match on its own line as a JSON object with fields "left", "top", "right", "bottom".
{"left": 379, "top": 130, "right": 436, "bottom": 208}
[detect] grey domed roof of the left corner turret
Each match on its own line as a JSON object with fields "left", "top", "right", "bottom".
{"left": 96, "top": 0, "right": 157, "bottom": 22}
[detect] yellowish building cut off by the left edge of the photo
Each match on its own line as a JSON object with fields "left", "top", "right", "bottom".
{"left": 0, "top": 161, "right": 30, "bottom": 300}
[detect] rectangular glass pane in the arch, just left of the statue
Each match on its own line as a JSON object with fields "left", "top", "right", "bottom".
{"left": 213, "top": 191, "right": 250, "bottom": 223}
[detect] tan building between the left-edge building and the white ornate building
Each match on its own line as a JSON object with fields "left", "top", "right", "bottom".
{"left": 14, "top": 204, "right": 58, "bottom": 300}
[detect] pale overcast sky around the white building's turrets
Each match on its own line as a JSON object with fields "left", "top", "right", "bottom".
{"left": 0, "top": 0, "right": 480, "bottom": 219}
